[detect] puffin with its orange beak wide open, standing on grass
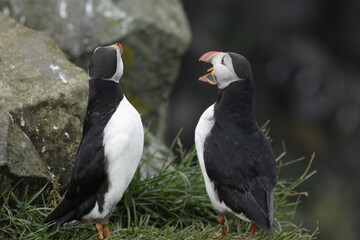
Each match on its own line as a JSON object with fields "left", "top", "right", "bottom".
{"left": 195, "top": 51, "right": 277, "bottom": 237}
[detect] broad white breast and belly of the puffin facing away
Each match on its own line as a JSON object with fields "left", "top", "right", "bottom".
{"left": 83, "top": 96, "right": 144, "bottom": 221}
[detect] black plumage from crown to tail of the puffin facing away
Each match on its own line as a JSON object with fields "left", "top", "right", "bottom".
{"left": 45, "top": 47, "right": 124, "bottom": 232}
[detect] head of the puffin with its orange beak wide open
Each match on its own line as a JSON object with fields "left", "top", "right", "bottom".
{"left": 199, "top": 51, "right": 253, "bottom": 89}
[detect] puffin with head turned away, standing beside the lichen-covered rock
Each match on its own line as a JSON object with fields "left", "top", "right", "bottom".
{"left": 44, "top": 43, "right": 144, "bottom": 239}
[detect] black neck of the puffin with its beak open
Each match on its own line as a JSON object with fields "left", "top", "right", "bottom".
{"left": 215, "top": 81, "right": 255, "bottom": 125}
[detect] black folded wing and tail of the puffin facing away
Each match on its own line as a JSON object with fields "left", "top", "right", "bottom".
{"left": 45, "top": 128, "right": 108, "bottom": 232}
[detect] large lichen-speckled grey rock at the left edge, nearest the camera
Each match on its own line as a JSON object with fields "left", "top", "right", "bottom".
{"left": 0, "top": 14, "right": 87, "bottom": 190}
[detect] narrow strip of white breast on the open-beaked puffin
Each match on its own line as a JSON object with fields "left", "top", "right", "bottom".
{"left": 195, "top": 105, "right": 249, "bottom": 221}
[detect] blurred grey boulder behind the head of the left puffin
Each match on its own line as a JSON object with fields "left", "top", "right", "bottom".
{"left": 4, "top": 0, "right": 191, "bottom": 137}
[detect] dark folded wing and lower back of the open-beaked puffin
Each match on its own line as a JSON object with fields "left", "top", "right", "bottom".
{"left": 204, "top": 123, "right": 276, "bottom": 232}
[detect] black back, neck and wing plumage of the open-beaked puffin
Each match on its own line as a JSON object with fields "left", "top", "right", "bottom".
{"left": 204, "top": 77, "right": 276, "bottom": 232}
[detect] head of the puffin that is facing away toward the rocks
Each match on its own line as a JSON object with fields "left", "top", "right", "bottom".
{"left": 89, "top": 43, "right": 124, "bottom": 83}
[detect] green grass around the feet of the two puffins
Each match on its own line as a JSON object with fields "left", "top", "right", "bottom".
{"left": 0, "top": 132, "right": 318, "bottom": 240}
